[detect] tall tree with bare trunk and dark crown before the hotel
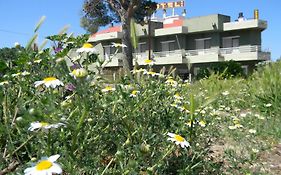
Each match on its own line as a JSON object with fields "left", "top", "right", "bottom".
{"left": 81, "top": 0, "right": 157, "bottom": 72}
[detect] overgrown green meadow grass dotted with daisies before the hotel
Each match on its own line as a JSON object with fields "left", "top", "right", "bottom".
{"left": 0, "top": 35, "right": 281, "bottom": 175}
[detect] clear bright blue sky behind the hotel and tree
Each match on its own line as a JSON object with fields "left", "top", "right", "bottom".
{"left": 0, "top": 0, "right": 281, "bottom": 60}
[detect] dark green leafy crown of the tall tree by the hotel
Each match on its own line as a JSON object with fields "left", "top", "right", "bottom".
{"left": 80, "top": 0, "right": 157, "bottom": 33}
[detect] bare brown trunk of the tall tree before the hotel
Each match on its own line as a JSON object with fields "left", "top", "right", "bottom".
{"left": 122, "top": 15, "right": 133, "bottom": 75}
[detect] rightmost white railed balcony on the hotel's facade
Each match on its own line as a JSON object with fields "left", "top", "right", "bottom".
{"left": 220, "top": 45, "right": 271, "bottom": 61}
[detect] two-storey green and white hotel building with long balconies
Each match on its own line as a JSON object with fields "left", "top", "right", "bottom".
{"left": 89, "top": 11, "right": 270, "bottom": 78}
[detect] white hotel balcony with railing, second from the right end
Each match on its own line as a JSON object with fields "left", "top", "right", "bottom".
{"left": 186, "top": 48, "right": 223, "bottom": 64}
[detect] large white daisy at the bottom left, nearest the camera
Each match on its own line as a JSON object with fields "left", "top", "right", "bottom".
{"left": 24, "top": 154, "right": 62, "bottom": 175}
